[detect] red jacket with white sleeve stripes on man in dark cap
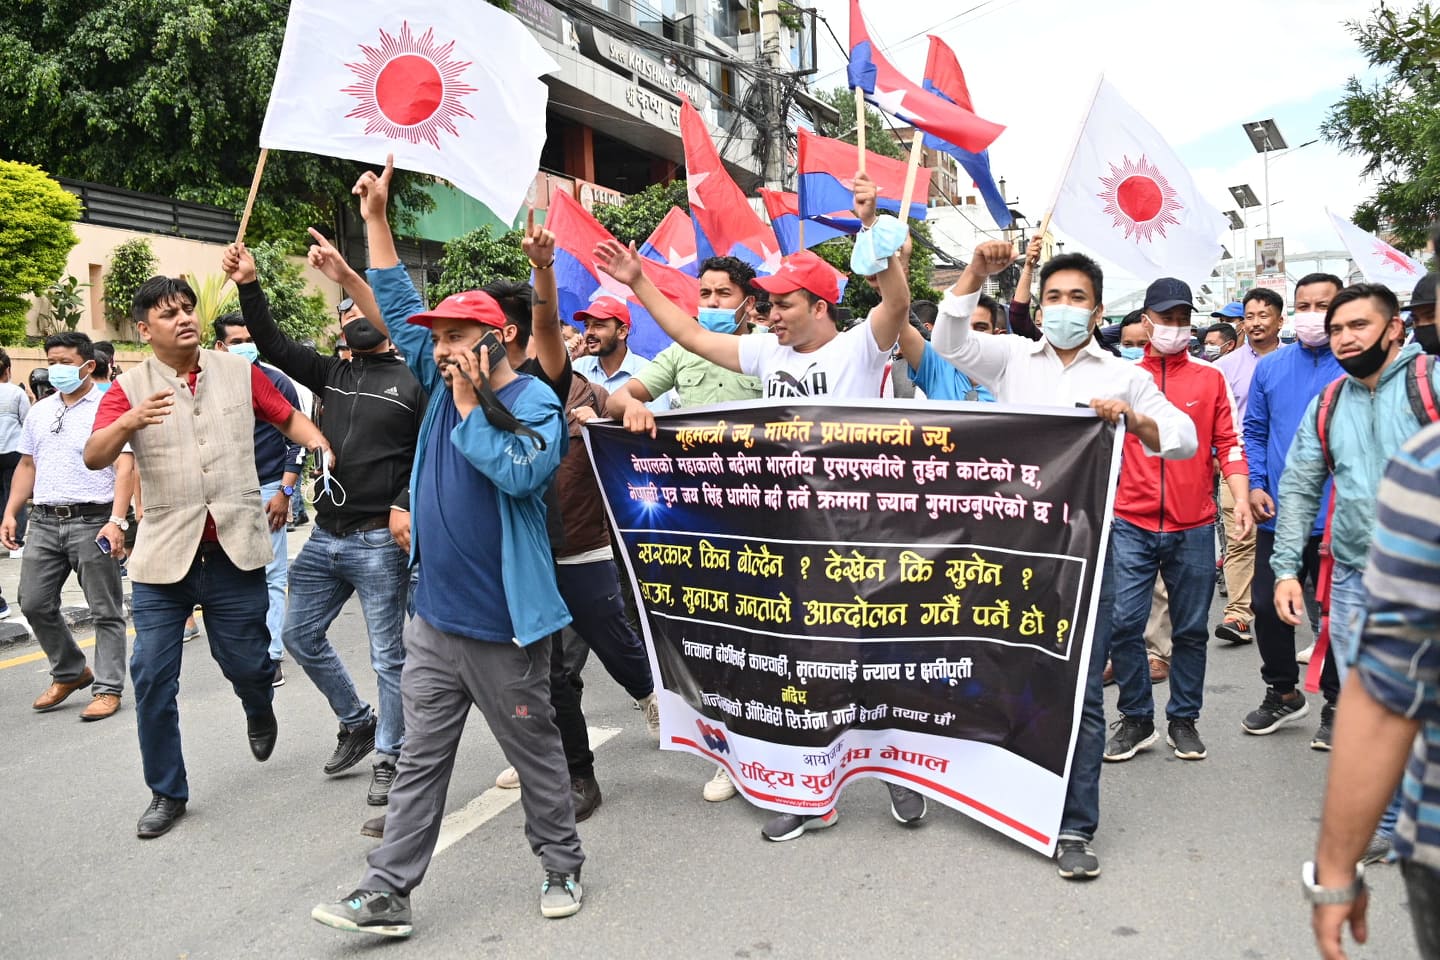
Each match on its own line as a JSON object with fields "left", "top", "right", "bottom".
{"left": 1115, "top": 348, "right": 1250, "bottom": 533}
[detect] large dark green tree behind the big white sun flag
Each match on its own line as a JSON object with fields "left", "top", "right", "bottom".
{"left": 0, "top": 0, "right": 455, "bottom": 252}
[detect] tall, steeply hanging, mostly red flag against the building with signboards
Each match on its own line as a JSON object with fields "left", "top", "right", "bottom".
{"left": 680, "top": 94, "right": 780, "bottom": 275}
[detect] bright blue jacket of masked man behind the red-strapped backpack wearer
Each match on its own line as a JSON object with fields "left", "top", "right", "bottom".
{"left": 1246, "top": 343, "right": 1345, "bottom": 537}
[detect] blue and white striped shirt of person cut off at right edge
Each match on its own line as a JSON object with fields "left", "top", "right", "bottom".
{"left": 1355, "top": 425, "right": 1440, "bottom": 869}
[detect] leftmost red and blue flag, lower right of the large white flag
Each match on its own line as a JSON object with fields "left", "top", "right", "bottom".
{"left": 544, "top": 191, "right": 700, "bottom": 358}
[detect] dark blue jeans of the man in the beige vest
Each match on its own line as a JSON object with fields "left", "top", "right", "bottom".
{"left": 130, "top": 545, "right": 275, "bottom": 800}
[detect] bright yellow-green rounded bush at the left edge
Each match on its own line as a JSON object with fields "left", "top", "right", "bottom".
{"left": 0, "top": 160, "right": 81, "bottom": 344}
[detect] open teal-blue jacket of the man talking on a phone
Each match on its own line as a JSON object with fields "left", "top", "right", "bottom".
{"left": 366, "top": 266, "right": 570, "bottom": 646}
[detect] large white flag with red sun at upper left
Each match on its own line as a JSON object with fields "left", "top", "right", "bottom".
{"left": 261, "top": 0, "right": 559, "bottom": 220}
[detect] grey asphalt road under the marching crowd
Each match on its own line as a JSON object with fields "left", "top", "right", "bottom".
{"left": 0, "top": 590, "right": 1416, "bottom": 960}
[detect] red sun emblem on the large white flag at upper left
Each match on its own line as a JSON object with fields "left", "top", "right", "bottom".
{"left": 340, "top": 23, "right": 475, "bottom": 150}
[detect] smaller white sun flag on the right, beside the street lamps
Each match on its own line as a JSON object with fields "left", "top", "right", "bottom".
{"left": 1051, "top": 81, "right": 1225, "bottom": 285}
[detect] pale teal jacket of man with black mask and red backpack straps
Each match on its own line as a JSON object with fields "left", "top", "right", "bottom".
{"left": 1270, "top": 344, "right": 1440, "bottom": 579}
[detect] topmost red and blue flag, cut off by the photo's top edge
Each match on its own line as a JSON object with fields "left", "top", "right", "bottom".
{"left": 848, "top": 0, "right": 1005, "bottom": 153}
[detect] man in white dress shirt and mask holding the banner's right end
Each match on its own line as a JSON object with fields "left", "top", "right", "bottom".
{"left": 932, "top": 240, "right": 1197, "bottom": 879}
